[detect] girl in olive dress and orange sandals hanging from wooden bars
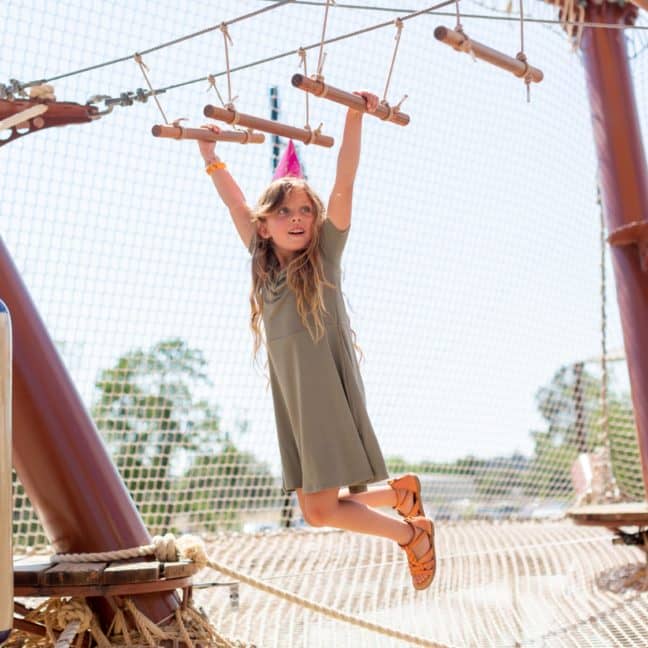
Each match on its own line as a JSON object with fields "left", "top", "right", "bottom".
{"left": 199, "top": 92, "right": 436, "bottom": 589}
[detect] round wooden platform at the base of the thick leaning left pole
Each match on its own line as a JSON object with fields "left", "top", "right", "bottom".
{"left": 13, "top": 558, "right": 199, "bottom": 596}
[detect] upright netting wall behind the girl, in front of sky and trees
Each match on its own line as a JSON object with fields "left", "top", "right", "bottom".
{"left": 0, "top": 0, "right": 648, "bottom": 645}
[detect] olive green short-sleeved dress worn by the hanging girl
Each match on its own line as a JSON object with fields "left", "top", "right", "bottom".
{"left": 250, "top": 219, "right": 388, "bottom": 493}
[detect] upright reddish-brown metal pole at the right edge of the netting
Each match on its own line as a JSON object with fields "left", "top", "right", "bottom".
{"left": 581, "top": 2, "right": 648, "bottom": 492}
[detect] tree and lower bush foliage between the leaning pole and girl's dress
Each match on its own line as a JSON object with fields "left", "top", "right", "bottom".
{"left": 92, "top": 338, "right": 273, "bottom": 533}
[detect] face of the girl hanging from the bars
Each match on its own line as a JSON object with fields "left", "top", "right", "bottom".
{"left": 259, "top": 188, "right": 315, "bottom": 267}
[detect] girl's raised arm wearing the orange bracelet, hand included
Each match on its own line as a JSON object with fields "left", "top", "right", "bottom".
{"left": 198, "top": 124, "right": 256, "bottom": 248}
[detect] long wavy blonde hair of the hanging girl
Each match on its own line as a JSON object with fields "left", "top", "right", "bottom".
{"left": 250, "top": 177, "right": 335, "bottom": 357}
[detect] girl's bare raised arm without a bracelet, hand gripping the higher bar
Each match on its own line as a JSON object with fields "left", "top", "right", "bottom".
{"left": 327, "top": 92, "right": 378, "bottom": 230}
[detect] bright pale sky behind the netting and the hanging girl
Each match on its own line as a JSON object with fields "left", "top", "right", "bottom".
{"left": 0, "top": 0, "right": 636, "bottom": 476}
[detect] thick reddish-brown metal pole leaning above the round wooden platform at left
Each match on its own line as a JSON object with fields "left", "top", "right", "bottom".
{"left": 0, "top": 239, "right": 179, "bottom": 621}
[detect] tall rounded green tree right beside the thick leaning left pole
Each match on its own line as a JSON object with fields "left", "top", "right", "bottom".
{"left": 92, "top": 339, "right": 223, "bottom": 530}
